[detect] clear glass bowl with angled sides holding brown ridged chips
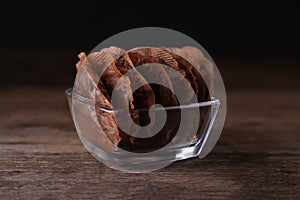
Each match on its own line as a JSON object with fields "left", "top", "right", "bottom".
{"left": 65, "top": 88, "right": 221, "bottom": 172}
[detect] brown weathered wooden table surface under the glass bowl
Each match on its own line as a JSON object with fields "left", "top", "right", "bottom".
{"left": 0, "top": 54, "right": 300, "bottom": 199}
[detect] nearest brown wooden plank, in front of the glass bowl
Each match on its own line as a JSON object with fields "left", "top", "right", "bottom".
{"left": 0, "top": 152, "right": 300, "bottom": 199}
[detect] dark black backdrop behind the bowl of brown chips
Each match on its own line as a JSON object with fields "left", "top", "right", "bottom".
{"left": 0, "top": 1, "right": 300, "bottom": 88}
